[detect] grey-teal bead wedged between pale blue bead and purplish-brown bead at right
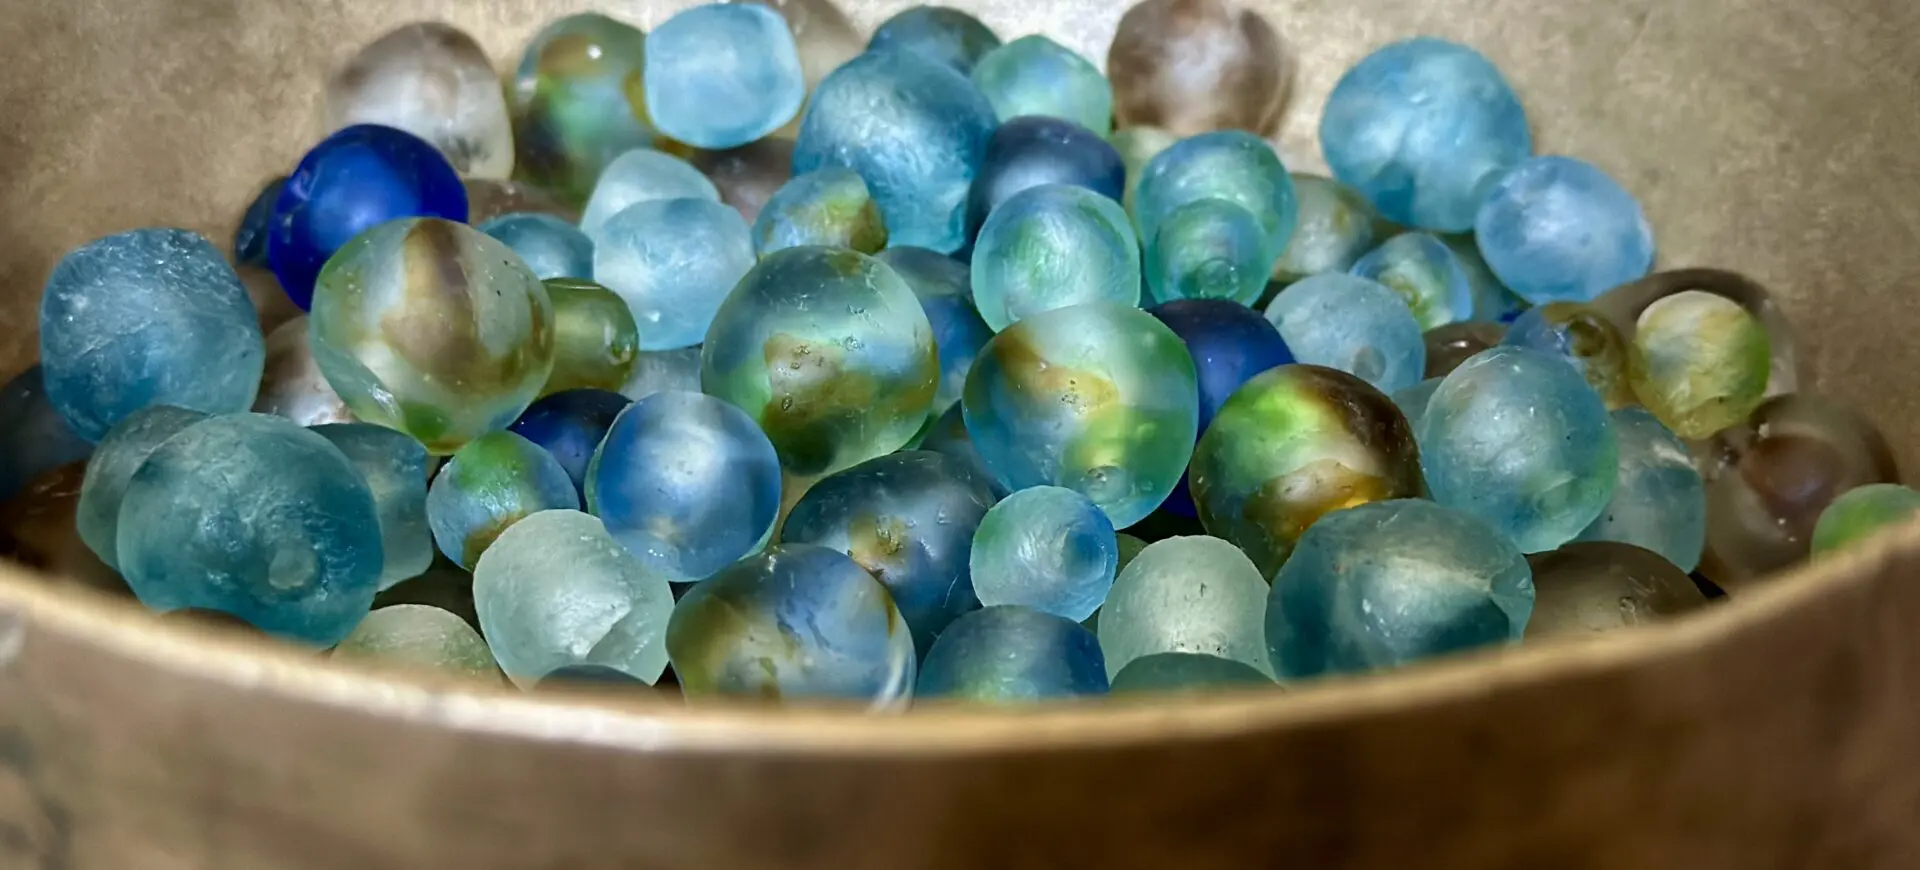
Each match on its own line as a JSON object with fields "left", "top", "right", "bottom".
{"left": 1578, "top": 407, "right": 1707, "bottom": 572}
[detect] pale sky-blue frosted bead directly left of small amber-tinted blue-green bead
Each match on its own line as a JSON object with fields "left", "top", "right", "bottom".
{"left": 593, "top": 200, "right": 755, "bottom": 350}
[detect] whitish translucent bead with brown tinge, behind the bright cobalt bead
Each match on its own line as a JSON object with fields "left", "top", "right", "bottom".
{"left": 326, "top": 21, "right": 513, "bottom": 179}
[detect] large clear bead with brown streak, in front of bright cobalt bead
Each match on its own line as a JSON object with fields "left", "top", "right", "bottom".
{"left": 309, "top": 219, "right": 553, "bottom": 455}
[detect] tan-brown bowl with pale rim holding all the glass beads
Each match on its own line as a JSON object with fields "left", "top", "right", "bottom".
{"left": 0, "top": 0, "right": 1920, "bottom": 870}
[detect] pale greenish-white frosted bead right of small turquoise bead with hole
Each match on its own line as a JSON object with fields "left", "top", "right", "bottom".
{"left": 1100, "top": 536, "right": 1273, "bottom": 676}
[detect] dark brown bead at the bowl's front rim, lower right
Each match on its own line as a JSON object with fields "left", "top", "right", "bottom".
{"left": 1526, "top": 542, "right": 1707, "bottom": 641}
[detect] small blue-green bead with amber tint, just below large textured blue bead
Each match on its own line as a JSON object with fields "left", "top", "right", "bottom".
{"left": 753, "top": 167, "right": 887, "bottom": 257}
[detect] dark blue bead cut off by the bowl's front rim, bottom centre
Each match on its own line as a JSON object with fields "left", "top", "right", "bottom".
{"left": 916, "top": 605, "right": 1108, "bottom": 705}
